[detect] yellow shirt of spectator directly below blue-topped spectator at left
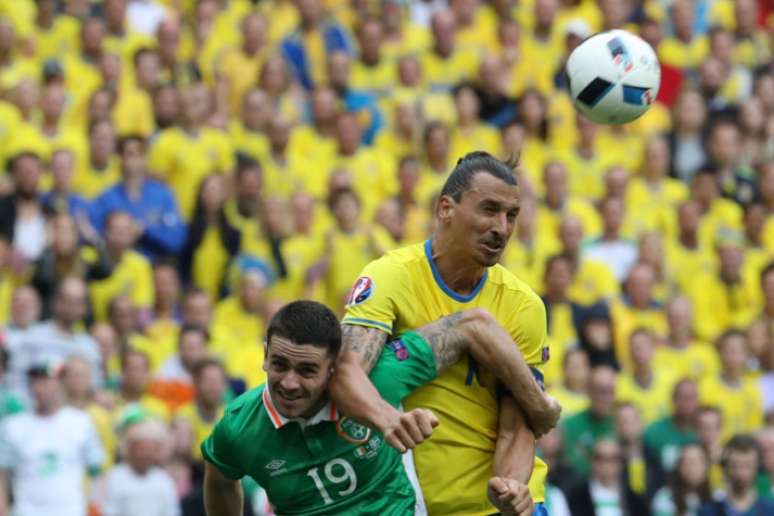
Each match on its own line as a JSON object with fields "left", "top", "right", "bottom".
{"left": 90, "top": 250, "right": 153, "bottom": 322}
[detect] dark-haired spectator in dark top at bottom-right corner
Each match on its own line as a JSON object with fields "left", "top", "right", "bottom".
{"left": 698, "top": 434, "right": 774, "bottom": 516}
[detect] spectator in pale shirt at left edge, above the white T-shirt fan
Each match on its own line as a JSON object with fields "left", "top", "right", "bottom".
{"left": 7, "top": 276, "right": 102, "bottom": 399}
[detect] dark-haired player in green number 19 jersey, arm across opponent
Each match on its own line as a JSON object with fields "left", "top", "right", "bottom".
{"left": 201, "top": 301, "right": 548, "bottom": 516}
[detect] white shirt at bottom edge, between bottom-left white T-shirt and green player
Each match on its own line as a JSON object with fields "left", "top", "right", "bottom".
{"left": 102, "top": 464, "right": 180, "bottom": 516}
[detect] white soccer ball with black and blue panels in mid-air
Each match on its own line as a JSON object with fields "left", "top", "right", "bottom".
{"left": 567, "top": 30, "right": 661, "bottom": 124}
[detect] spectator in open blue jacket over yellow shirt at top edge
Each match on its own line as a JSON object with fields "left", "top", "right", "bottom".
{"left": 280, "top": 0, "right": 352, "bottom": 90}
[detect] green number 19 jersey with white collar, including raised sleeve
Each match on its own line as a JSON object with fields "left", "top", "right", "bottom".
{"left": 201, "top": 333, "right": 436, "bottom": 515}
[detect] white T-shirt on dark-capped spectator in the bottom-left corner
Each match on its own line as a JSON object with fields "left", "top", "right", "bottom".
{"left": 0, "top": 407, "right": 104, "bottom": 516}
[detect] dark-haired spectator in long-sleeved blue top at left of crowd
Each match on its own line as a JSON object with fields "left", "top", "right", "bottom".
{"left": 92, "top": 136, "right": 186, "bottom": 259}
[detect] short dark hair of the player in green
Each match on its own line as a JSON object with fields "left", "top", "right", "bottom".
{"left": 266, "top": 301, "right": 341, "bottom": 356}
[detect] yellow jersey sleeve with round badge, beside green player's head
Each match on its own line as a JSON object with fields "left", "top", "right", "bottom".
{"left": 342, "top": 255, "right": 412, "bottom": 335}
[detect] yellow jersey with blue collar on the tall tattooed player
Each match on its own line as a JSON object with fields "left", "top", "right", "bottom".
{"left": 343, "top": 240, "right": 547, "bottom": 510}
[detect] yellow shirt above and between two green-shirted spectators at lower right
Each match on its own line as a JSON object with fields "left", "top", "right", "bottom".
{"left": 615, "top": 368, "right": 677, "bottom": 426}
